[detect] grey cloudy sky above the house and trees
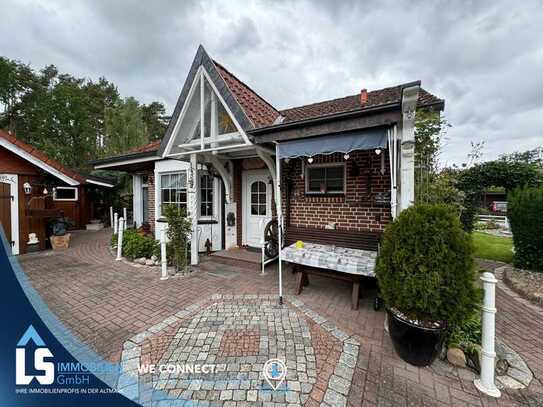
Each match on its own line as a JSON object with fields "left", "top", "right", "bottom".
{"left": 0, "top": 0, "right": 543, "bottom": 165}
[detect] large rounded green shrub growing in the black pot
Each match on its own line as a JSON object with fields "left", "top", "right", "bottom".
{"left": 376, "top": 204, "right": 479, "bottom": 327}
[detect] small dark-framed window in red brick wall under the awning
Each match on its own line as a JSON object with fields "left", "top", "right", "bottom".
{"left": 305, "top": 164, "right": 345, "bottom": 194}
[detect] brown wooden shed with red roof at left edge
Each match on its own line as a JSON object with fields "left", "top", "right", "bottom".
{"left": 0, "top": 130, "right": 114, "bottom": 254}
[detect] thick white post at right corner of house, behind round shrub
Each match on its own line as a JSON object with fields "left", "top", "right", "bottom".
{"left": 400, "top": 85, "right": 420, "bottom": 211}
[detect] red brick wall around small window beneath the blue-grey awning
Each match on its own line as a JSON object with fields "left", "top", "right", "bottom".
{"left": 281, "top": 150, "right": 391, "bottom": 231}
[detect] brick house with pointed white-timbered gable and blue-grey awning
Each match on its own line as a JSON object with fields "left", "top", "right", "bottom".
{"left": 93, "top": 46, "right": 444, "bottom": 264}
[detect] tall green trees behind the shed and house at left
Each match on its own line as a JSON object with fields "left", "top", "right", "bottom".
{"left": 0, "top": 56, "right": 168, "bottom": 170}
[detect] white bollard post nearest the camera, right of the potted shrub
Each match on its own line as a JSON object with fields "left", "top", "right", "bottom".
{"left": 473, "top": 272, "right": 501, "bottom": 397}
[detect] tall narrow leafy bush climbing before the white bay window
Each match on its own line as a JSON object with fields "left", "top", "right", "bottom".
{"left": 162, "top": 205, "right": 192, "bottom": 269}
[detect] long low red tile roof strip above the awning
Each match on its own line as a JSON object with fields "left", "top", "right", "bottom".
{"left": 280, "top": 86, "right": 443, "bottom": 123}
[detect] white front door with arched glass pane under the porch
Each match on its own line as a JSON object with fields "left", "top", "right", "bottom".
{"left": 242, "top": 170, "right": 272, "bottom": 247}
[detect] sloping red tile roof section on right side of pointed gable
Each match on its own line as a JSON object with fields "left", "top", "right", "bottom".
{"left": 213, "top": 61, "right": 279, "bottom": 128}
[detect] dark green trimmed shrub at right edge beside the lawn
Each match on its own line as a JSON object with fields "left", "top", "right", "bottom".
{"left": 507, "top": 187, "right": 543, "bottom": 272}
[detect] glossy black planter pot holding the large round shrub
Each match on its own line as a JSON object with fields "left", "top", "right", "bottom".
{"left": 387, "top": 309, "right": 446, "bottom": 366}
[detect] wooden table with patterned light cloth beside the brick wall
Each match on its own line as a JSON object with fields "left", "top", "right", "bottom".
{"left": 282, "top": 243, "right": 377, "bottom": 309}
